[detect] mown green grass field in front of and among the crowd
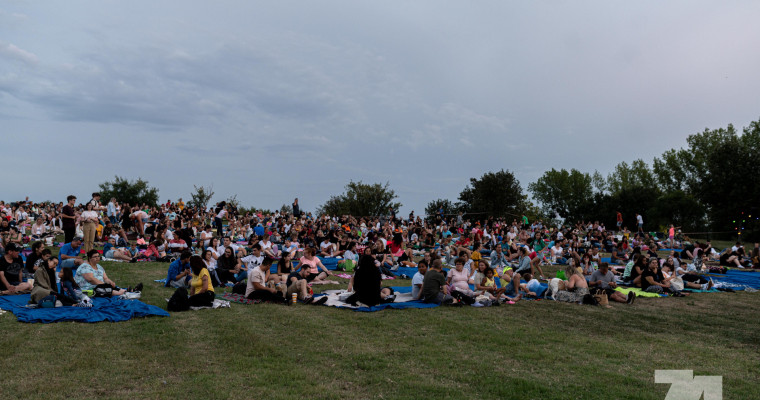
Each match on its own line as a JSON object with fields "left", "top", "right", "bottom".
{"left": 0, "top": 248, "right": 760, "bottom": 399}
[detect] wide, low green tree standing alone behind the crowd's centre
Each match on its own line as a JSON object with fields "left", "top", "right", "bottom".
{"left": 317, "top": 181, "right": 401, "bottom": 216}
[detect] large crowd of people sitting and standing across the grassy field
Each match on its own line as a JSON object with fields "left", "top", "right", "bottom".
{"left": 0, "top": 193, "right": 760, "bottom": 306}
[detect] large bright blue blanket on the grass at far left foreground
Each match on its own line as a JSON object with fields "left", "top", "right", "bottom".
{"left": 0, "top": 294, "right": 169, "bottom": 324}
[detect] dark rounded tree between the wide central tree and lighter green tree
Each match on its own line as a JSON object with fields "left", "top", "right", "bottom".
{"left": 459, "top": 170, "right": 526, "bottom": 219}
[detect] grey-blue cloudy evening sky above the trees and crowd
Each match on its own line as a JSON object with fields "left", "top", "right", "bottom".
{"left": 0, "top": 0, "right": 760, "bottom": 214}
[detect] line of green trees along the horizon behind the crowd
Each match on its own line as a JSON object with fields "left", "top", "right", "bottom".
{"left": 100, "top": 120, "right": 760, "bottom": 240}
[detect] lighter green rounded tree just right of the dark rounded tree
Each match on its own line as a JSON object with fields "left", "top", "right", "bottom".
{"left": 528, "top": 168, "right": 593, "bottom": 221}
